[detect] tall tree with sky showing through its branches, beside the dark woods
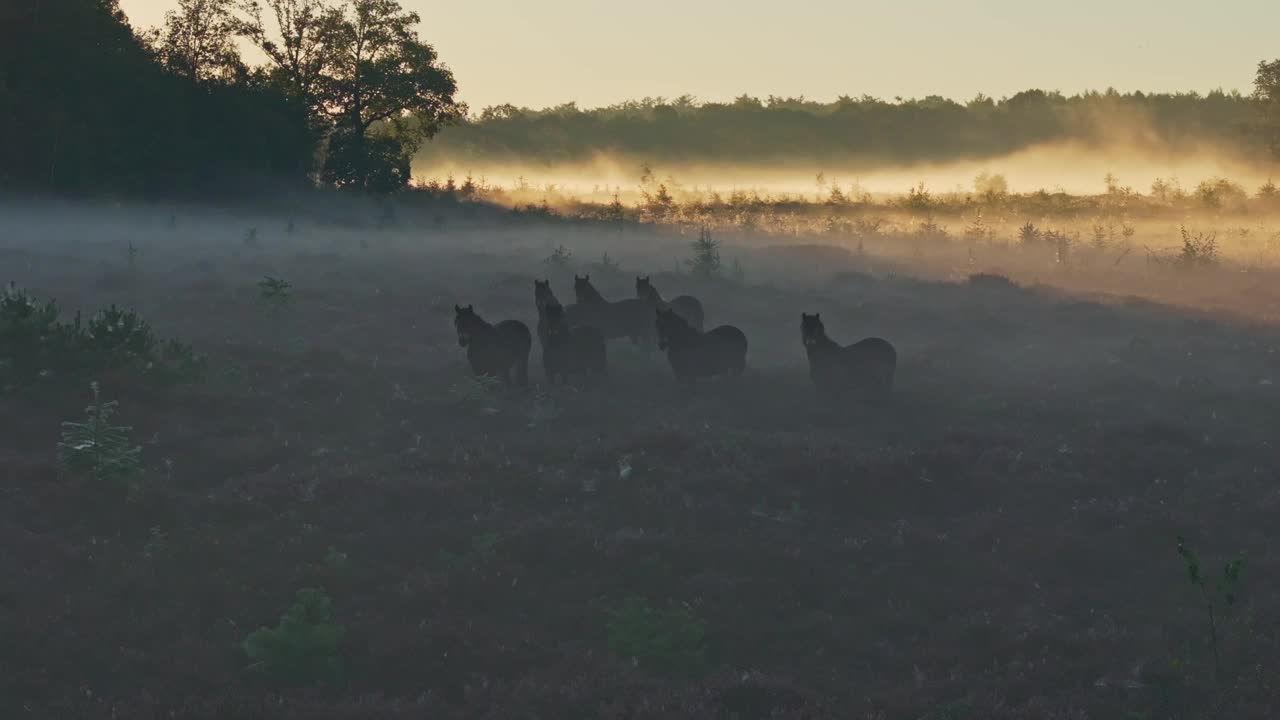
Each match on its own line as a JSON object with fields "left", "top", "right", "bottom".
{"left": 242, "top": 0, "right": 465, "bottom": 191}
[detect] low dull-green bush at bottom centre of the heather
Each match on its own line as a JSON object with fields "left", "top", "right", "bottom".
{"left": 608, "top": 596, "right": 707, "bottom": 675}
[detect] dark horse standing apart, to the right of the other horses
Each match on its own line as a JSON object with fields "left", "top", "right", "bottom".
{"left": 800, "top": 313, "right": 897, "bottom": 401}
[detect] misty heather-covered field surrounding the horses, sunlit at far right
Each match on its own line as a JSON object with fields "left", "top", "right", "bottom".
{"left": 0, "top": 188, "right": 1280, "bottom": 720}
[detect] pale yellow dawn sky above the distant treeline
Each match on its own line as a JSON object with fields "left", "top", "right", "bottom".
{"left": 120, "top": 0, "right": 1280, "bottom": 111}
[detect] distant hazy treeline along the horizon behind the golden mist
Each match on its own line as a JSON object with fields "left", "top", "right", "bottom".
{"left": 417, "top": 90, "right": 1256, "bottom": 167}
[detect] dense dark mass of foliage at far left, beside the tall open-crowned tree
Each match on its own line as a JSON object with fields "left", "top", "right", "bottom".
{"left": 0, "top": 0, "right": 314, "bottom": 196}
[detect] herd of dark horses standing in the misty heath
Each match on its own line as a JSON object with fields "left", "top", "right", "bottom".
{"left": 453, "top": 275, "right": 897, "bottom": 401}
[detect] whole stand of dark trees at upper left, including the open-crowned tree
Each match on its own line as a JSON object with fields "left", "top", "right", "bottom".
{"left": 0, "top": 0, "right": 465, "bottom": 195}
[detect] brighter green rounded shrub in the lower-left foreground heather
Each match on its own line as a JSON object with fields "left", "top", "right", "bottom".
{"left": 243, "top": 588, "right": 346, "bottom": 687}
